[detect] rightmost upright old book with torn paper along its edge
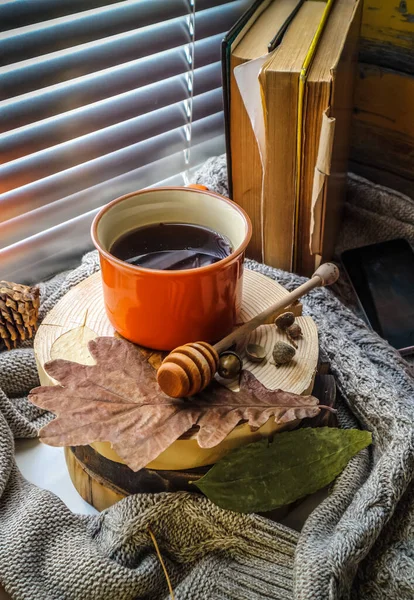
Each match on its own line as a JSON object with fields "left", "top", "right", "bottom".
{"left": 294, "top": 0, "right": 362, "bottom": 276}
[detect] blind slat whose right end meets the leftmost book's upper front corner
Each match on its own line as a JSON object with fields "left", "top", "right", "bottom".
{"left": 0, "top": 34, "right": 222, "bottom": 133}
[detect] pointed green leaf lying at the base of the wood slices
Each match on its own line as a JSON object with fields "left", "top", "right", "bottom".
{"left": 195, "top": 427, "right": 372, "bottom": 513}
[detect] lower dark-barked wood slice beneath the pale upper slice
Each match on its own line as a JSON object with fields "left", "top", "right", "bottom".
{"left": 65, "top": 376, "right": 336, "bottom": 510}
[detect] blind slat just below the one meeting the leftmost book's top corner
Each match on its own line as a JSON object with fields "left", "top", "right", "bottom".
{"left": 0, "top": 62, "right": 221, "bottom": 164}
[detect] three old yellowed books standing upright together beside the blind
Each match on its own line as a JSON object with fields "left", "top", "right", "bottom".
{"left": 223, "top": 0, "right": 362, "bottom": 275}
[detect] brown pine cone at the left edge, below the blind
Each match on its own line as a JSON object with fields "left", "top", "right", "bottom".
{"left": 0, "top": 281, "right": 40, "bottom": 350}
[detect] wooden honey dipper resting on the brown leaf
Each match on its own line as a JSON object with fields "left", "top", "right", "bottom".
{"left": 157, "top": 263, "right": 339, "bottom": 398}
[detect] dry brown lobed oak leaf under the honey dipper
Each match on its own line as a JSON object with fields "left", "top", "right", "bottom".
{"left": 29, "top": 337, "right": 321, "bottom": 471}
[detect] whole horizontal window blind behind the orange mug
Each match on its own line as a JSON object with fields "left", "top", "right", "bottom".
{"left": 0, "top": 0, "right": 250, "bottom": 282}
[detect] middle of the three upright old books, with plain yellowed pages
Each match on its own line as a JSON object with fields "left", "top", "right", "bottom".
{"left": 259, "top": 0, "right": 326, "bottom": 271}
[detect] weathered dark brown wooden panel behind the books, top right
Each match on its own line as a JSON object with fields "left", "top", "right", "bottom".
{"left": 350, "top": 0, "right": 414, "bottom": 189}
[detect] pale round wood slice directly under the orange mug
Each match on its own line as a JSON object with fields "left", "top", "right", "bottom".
{"left": 34, "top": 270, "right": 324, "bottom": 508}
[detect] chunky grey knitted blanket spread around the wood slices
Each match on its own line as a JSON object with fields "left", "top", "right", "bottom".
{"left": 0, "top": 162, "right": 414, "bottom": 600}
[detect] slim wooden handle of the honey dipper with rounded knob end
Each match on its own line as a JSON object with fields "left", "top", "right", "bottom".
{"left": 213, "top": 263, "right": 339, "bottom": 354}
